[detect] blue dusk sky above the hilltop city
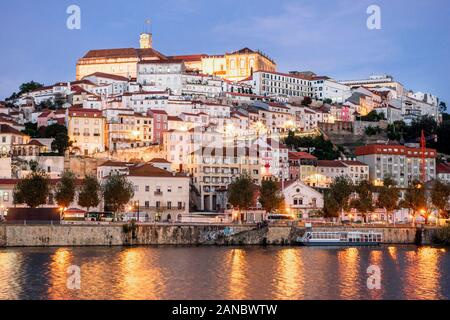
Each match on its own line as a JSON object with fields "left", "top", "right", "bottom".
{"left": 0, "top": 0, "right": 450, "bottom": 103}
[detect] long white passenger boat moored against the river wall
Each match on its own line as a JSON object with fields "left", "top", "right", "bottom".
{"left": 297, "top": 231, "right": 383, "bottom": 246}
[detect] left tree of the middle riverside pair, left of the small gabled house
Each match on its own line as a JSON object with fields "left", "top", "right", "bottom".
{"left": 228, "top": 174, "right": 255, "bottom": 210}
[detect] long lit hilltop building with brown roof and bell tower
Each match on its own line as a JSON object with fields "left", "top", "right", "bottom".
{"left": 76, "top": 33, "right": 167, "bottom": 80}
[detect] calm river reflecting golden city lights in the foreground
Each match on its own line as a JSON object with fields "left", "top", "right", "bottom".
{"left": 0, "top": 246, "right": 450, "bottom": 300}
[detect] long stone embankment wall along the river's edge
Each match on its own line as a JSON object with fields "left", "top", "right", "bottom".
{"left": 0, "top": 224, "right": 434, "bottom": 247}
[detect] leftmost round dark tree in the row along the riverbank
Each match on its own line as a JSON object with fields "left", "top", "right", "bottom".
{"left": 13, "top": 171, "right": 50, "bottom": 208}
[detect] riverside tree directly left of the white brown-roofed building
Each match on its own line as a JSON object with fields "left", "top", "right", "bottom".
{"left": 103, "top": 174, "right": 134, "bottom": 219}
